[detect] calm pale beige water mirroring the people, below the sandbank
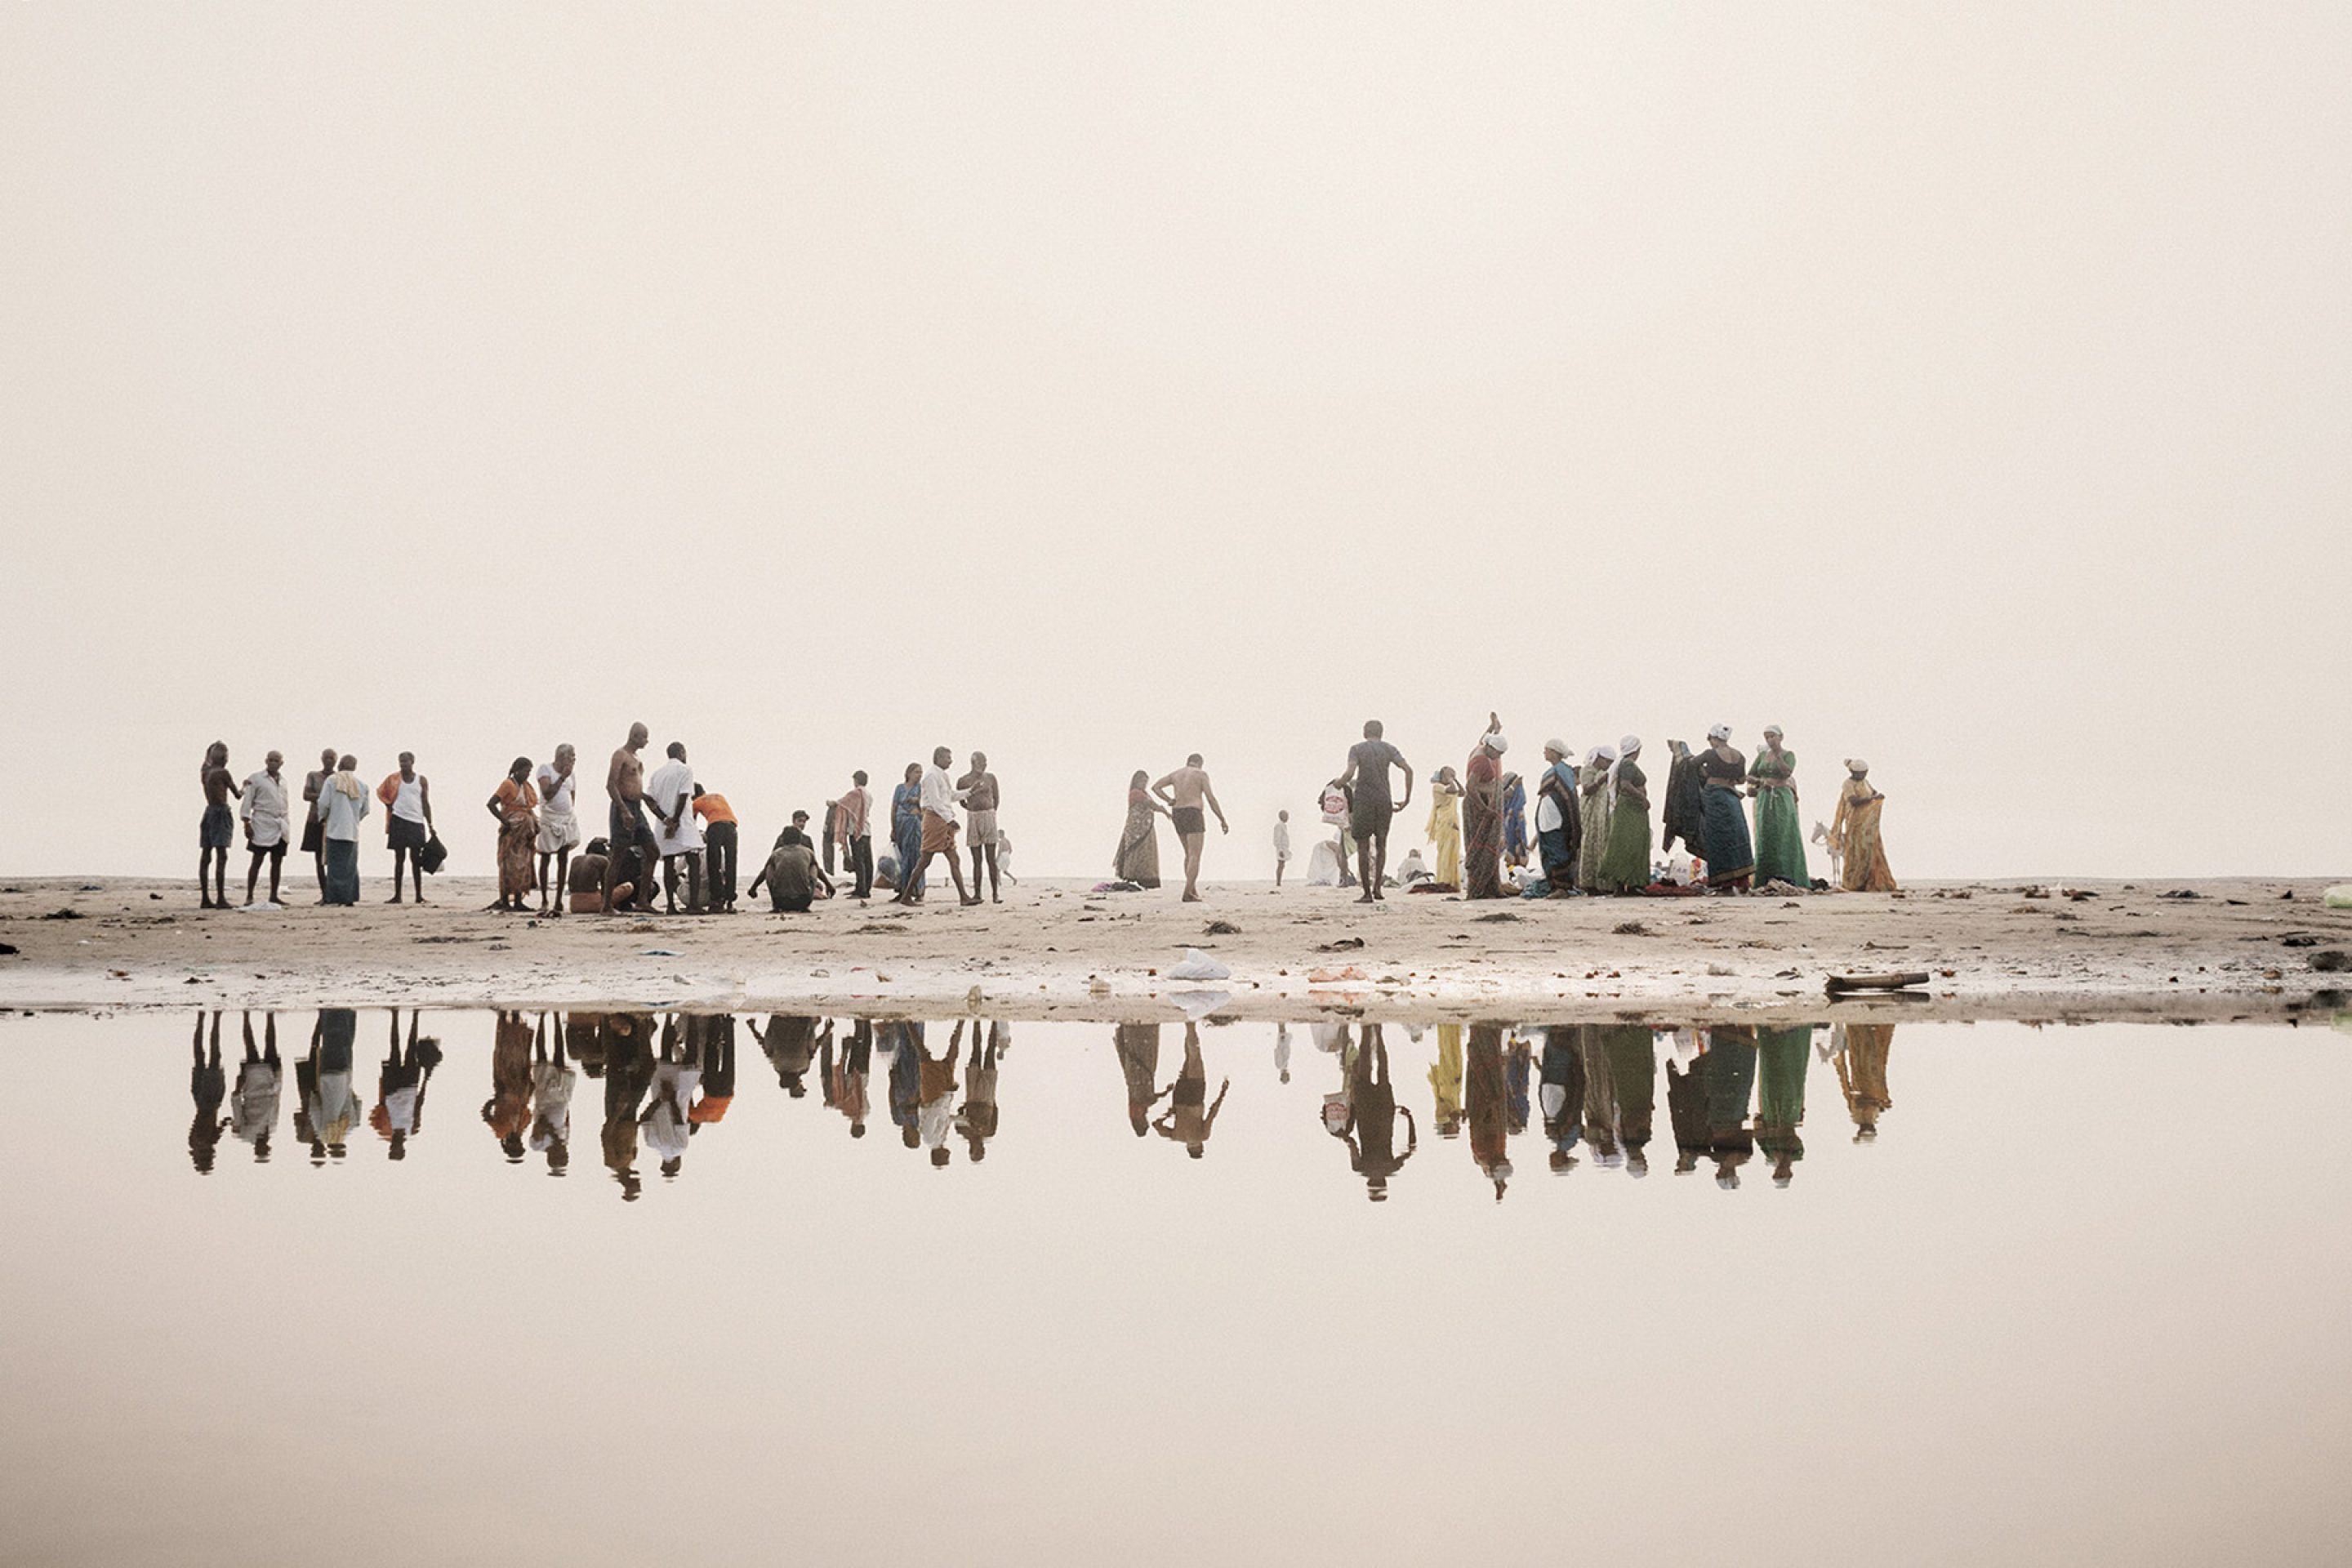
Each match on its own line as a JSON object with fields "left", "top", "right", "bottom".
{"left": 0, "top": 1011, "right": 2352, "bottom": 1566}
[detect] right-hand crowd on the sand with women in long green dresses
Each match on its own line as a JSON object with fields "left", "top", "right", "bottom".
{"left": 1279, "top": 715, "right": 1895, "bottom": 902}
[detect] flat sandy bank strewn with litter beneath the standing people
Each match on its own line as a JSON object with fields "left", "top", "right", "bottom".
{"left": 0, "top": 880, "right": 2352, "bottom": 1022}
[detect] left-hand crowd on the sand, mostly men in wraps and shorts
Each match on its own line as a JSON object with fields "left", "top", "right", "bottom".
{"left": 198, "top": 724, "right": 1009, "bottom": 917}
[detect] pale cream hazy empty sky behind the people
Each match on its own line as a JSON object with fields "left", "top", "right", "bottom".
{"left": 0, "top": 0, "right": 2352, "bottom": 877}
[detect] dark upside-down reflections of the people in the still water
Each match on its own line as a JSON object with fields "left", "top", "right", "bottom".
{"left": 174, "top": 1009, "right": 1893, "bottom": 1204}
